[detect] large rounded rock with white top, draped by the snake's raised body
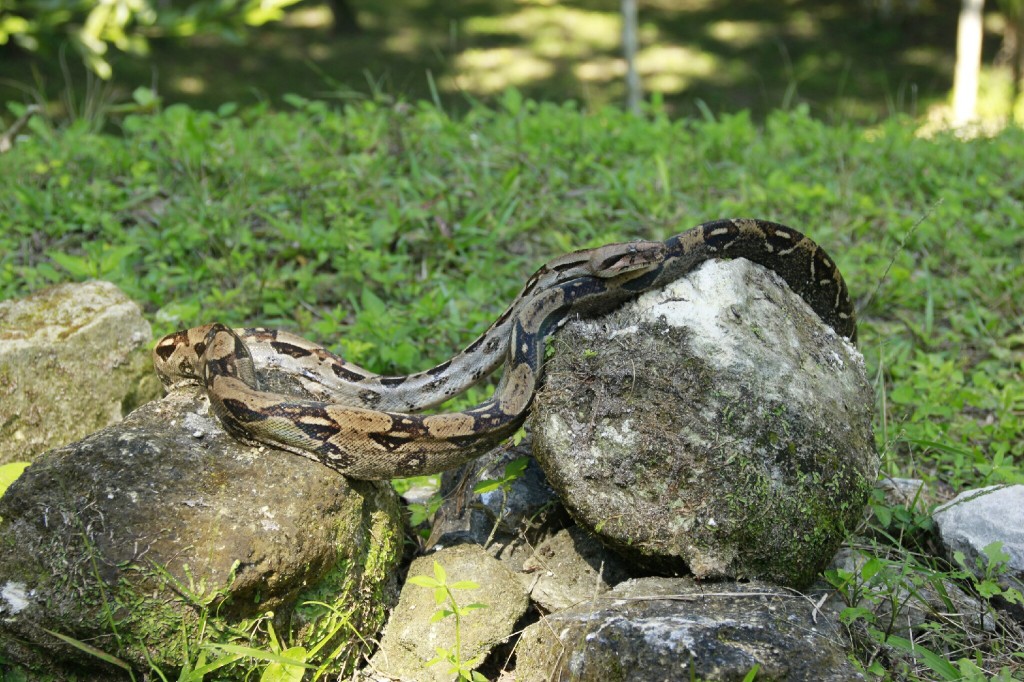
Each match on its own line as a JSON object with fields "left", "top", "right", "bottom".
{"left": 534, "top": 260, "right": 879, "bottom": 587}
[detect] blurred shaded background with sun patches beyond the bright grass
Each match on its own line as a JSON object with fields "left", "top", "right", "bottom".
{"left": 0, "top": 0, "right": 1024, "bottom": 123}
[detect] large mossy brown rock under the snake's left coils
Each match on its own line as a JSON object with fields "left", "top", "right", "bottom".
{"left": 0, "top": 390, "right": 402, "bottom": 680}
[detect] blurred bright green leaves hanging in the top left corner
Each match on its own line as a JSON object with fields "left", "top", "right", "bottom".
{"left": 0, "top": 0, "right": 298, "bottom": 79}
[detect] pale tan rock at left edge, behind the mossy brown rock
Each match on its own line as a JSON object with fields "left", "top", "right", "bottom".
{"left": 0, "top": 282, "right": 162, "bottom": 464}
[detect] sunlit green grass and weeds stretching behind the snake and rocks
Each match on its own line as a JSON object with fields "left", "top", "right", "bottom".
{"left": 0, "top": 91, "right": 1024, "bottom": 679}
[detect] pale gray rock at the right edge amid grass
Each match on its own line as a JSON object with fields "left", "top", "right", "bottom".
{"left": 933, "top": 485, "right": 1024, "bottom": 621}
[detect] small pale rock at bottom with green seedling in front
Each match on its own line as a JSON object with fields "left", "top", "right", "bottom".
{"left": 371, "top": 545, "right": 529, "bottom": 682}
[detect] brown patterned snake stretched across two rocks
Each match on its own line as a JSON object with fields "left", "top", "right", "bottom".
{"left": 154, "top": 218, "right": 857, "bottom": 480}
